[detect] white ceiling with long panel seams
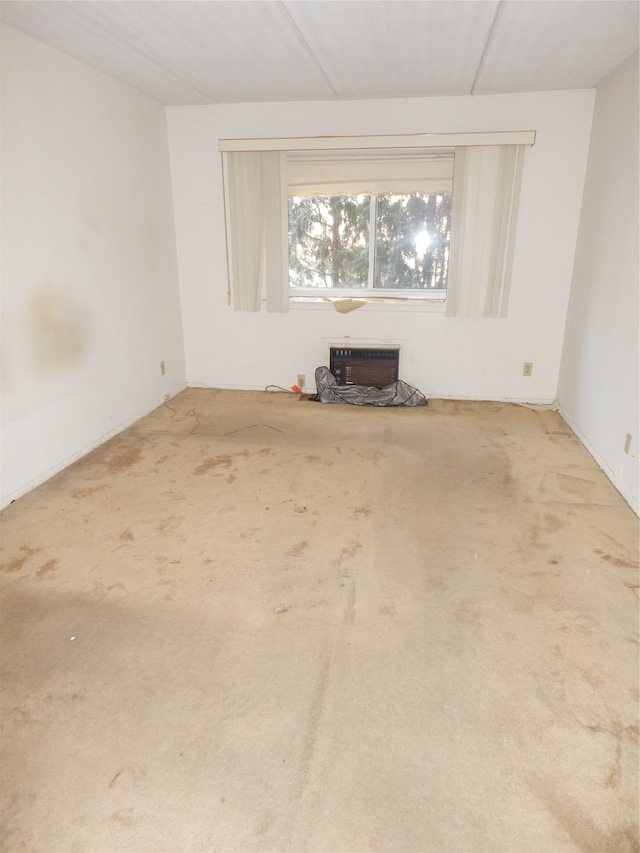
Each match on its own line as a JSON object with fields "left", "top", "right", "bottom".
{"left": 0, "top": 0, "right": 639, "bottom": 104}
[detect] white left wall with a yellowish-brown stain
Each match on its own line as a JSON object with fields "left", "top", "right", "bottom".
{"left": 2, "top": 26, "right": 186, "bottom": 504}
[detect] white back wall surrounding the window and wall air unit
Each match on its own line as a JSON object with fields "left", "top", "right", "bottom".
{"left": 168, "top": 91, "right": 594, "bottom": 402}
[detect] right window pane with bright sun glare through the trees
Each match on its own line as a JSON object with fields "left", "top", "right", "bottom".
{"left": 374, "top": 193, "right": 452, "bottom": 290}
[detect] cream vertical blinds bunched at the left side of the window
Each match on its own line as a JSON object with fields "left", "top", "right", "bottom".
{"left": 224, "top": 151, "right": 289, "bottom": 311}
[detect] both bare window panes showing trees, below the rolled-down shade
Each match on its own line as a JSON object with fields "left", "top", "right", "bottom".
{"left": 288, "top": 192, "right": 452, "bottom": 297}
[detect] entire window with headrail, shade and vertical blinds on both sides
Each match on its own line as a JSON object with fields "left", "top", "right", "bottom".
{"left": 219, "top": 131, "right": 535, "bottom": 318}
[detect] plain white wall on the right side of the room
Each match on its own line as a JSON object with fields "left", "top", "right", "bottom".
{"left": 559, "top": 53, "right": 640, "bottom": 512}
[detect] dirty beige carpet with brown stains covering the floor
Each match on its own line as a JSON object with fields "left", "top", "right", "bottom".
{"left": 1, "top": 389, "right": 639, "bottom": 853}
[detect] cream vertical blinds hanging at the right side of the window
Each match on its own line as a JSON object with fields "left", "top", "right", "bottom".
{"left": 445, "top": 145, "right": 525, "bottom": 317}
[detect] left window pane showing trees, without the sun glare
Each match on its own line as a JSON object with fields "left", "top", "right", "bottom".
{"left": 289, "top": 195, "right": 371, "bottom": 288}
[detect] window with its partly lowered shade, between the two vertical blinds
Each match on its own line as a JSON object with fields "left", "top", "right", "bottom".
{"left": 287, "top": 149, "right": 454, "bottom": 299}
